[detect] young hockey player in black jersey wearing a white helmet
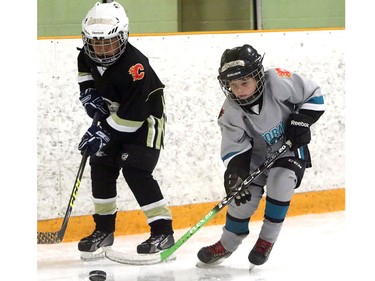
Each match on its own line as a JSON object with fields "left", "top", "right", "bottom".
{"left": 78, "top": 1, "right": 174, "bottom": 260}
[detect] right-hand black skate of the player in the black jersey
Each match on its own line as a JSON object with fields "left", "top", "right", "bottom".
{"left": 137, "top": 233, "right": 174, "bottom": 254}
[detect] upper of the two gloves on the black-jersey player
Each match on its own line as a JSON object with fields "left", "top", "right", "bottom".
{"left": 79, "top": 88, "right": 109, "bottom": 119}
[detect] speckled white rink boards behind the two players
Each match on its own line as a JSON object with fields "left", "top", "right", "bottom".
{"left": 37, "top": 30, "right": 345, "bottom": 219}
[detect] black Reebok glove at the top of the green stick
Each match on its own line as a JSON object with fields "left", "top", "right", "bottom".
{"left": 285, "top": 113, "right": 313, "bottom": 149}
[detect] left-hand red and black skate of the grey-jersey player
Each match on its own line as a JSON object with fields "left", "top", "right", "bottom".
{"left": 197, "top": 241, "right": 233, "bottom": 266}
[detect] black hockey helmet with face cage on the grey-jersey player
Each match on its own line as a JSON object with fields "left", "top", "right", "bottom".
{"left": 217, "top": 44, "right": 265, "bottom": 105}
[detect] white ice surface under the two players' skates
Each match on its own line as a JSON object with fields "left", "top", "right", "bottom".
{"left": 37, "top": 212, "right": 345, "bottom": 281}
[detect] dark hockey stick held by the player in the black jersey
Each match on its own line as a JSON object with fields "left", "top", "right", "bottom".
{"left": 36, "top": 112, "right": 100, "bottom": 244}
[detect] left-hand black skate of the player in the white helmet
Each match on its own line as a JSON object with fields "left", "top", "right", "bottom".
{"left": 78, "top": 230, "right": 114, "bottom": 261}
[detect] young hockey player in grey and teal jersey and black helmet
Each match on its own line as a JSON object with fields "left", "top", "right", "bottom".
{"left": 198, "top": 45, "right": 324, "bottom": 268}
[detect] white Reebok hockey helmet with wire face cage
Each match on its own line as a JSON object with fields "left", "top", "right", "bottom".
{"left": 82, "top": 1, "right": 129, "bottom": 66}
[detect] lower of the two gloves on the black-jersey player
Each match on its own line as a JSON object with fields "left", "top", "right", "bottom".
{"left": 78, "top": 125, "right": 110, "bottom": 156}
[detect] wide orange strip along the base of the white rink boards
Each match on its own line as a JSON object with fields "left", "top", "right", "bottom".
{"left": 37, "top": 188, "right": 345, "bottom": 242}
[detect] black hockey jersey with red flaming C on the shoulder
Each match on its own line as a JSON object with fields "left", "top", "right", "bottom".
{"left": 78, "top": 42, "right": 165, "bottom": 149}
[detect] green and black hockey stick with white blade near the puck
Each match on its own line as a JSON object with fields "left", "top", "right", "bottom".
{"left": 105, "top": 141, "right": 291, "bottom": 265}
